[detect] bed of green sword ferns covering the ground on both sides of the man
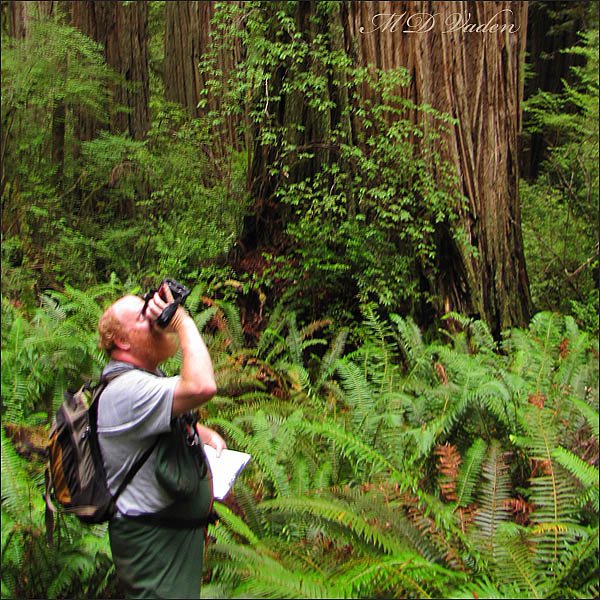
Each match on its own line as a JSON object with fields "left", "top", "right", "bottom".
{"left": 2, "top": 270, "right": 598, "bottom": 598}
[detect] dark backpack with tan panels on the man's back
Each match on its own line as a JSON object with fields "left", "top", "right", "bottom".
{"left": 44, "top": 365, "right": 156, "bottom": 539}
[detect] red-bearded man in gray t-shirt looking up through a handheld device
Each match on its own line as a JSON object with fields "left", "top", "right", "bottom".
{"left": 98, "top": 285, "right": 226, "bottom": 598}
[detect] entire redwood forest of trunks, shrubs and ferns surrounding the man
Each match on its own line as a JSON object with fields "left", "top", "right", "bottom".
{"left": 0, "top": 0, "right": 599, "bottom": 598}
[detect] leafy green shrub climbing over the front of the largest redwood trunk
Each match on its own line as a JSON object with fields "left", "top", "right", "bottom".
{"left": 203, "top": 2, "right": 461, "bottom": 318}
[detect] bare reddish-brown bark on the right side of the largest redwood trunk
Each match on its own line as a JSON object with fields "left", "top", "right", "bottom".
{"left": 346, "top": 1, "right": 531, "bottom": 332}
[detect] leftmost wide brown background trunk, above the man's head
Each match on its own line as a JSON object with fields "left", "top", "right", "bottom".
{"left": 72, "top": 0, "right": 150, "bottom": 140}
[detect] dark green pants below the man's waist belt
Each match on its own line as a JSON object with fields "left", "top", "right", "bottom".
{"left": 108, "top": 518, "right": 204, "bottom": 600}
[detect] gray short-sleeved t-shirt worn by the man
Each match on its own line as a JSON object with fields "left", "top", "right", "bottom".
{"left": 98, "top": 361, "right": 179, "bottom": 516}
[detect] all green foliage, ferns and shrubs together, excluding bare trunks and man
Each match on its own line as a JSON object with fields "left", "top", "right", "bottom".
{"left": 1, "top": 2, "right": 600, "bottom": 598}
